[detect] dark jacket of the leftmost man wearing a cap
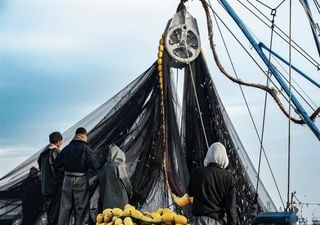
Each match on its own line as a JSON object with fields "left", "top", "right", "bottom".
{"left": 38, "top": 145, "right": 62, "bottom": 195}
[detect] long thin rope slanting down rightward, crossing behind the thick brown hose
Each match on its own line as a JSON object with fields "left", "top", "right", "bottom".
{"left": 213, "top": 3, "right": 285, "bottom": 208}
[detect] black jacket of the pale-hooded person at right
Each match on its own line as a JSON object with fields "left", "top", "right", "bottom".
{"left": 188, "top": 163, "right": 238, "bottom": 225}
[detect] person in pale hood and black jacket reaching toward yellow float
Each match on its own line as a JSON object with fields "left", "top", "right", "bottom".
{"left": 173, "top": 142, "right": 238, "bottom": 225}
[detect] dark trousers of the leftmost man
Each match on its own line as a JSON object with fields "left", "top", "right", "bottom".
{"left": 44, "top": 194, "right": 61, "bottom": 225}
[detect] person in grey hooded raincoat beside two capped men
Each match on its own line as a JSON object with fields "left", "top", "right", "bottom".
{"left": 99, "top": 144, "right": 132, "bottom": 209}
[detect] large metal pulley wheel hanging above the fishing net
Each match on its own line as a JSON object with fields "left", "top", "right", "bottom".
{"left": 165, "top": 10, "right": 200, "bottom": 67}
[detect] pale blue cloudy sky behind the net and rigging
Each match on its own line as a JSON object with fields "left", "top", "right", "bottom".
{"left": 0, "top": 0, "right": 320, "bottom": 221}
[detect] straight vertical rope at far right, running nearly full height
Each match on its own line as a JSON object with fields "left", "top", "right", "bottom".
{"left": 287, "top": 0, "right": 292, "bottom": 210}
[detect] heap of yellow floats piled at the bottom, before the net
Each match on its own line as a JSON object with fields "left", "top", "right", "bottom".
{"left": 96, "top": 204, "right": 188, "bottom": 225}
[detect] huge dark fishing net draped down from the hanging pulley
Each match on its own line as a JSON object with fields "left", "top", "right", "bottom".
{"left": 0, "top": 49, "right": 275, "bottom": 224}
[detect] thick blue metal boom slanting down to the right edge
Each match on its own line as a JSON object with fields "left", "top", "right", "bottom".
{"left": 220, "top": 0, "right": 320, "bottom": 140}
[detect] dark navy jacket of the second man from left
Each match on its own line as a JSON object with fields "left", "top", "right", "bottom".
{"left": 55, "top": 139, "right": 96, "bottom": 173}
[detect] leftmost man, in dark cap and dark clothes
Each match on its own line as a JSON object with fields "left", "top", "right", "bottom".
{"left": 38, "top": 131, "right": 63, "bottom": 225}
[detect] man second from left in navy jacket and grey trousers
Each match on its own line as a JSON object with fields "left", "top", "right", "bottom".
{"left": 55, "top": 127, "right": 95, "bottom": 225}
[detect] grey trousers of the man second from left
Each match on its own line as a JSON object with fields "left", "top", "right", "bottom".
{"left": 58, "top": 175, "right": 90, "bottom": 225}
